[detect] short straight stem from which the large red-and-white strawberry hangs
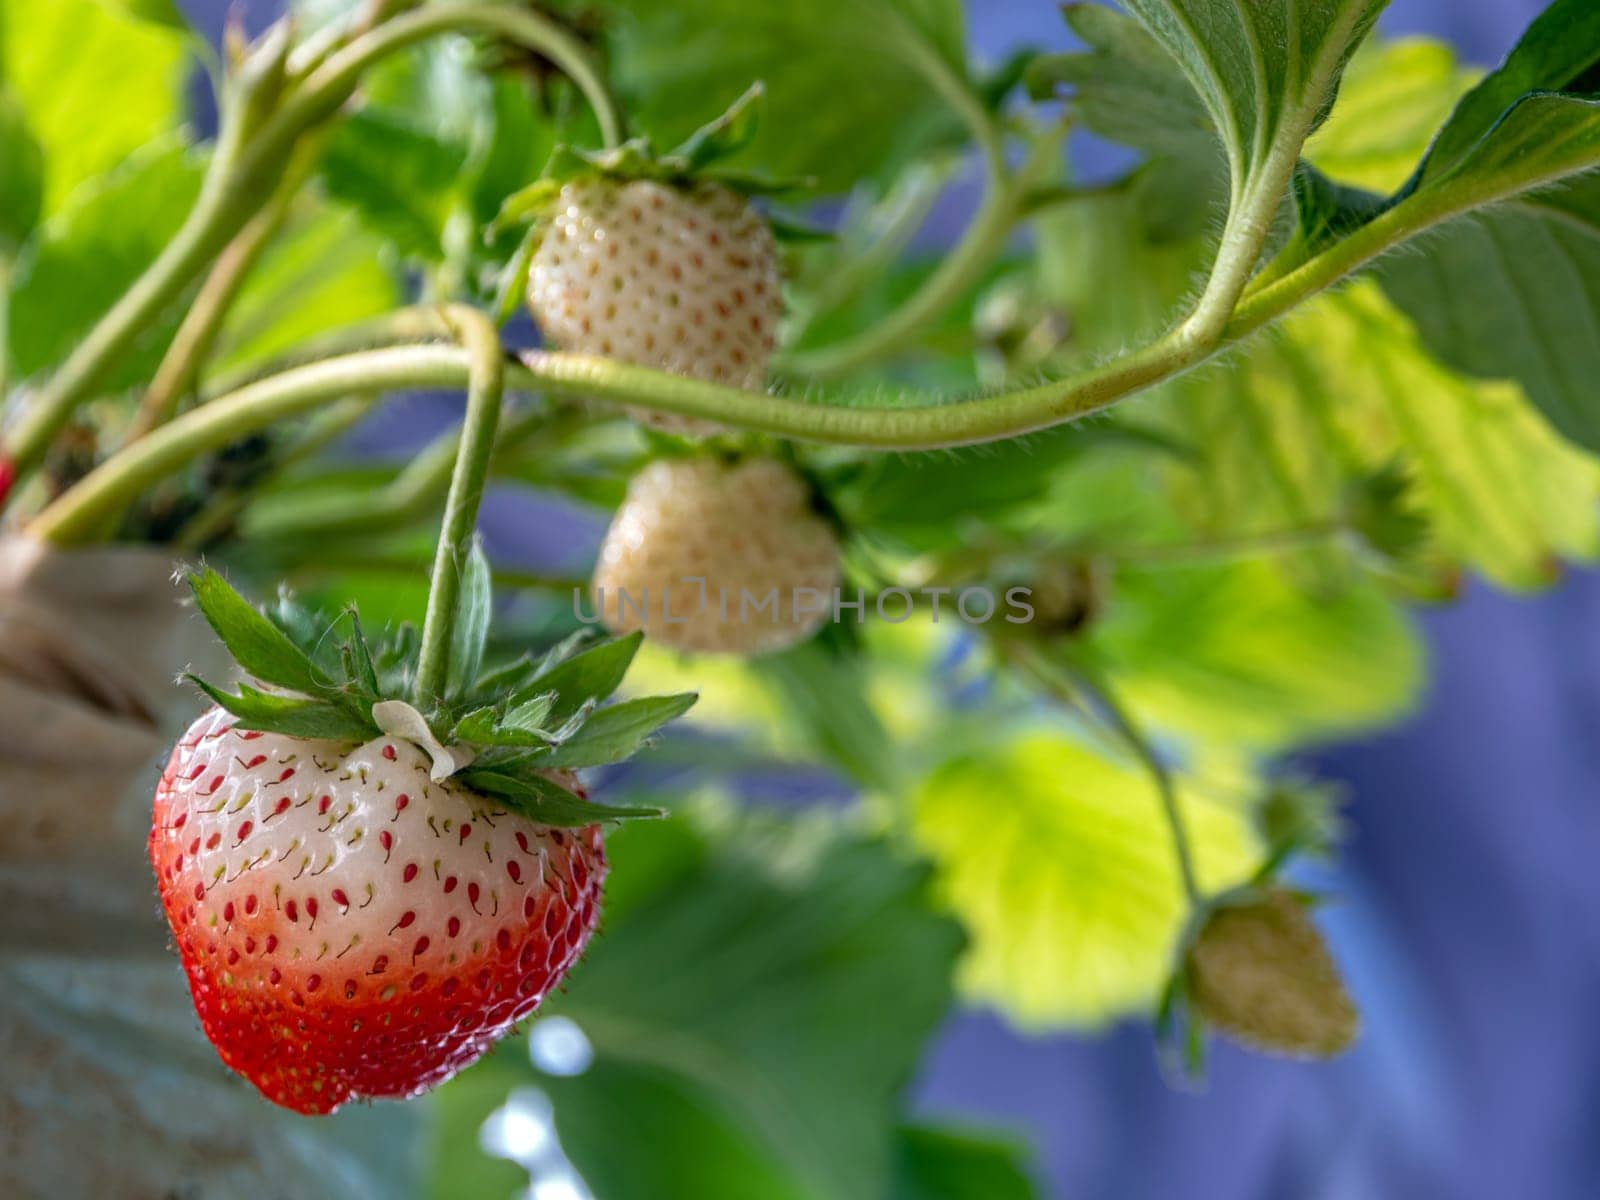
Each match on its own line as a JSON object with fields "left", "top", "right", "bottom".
{"left": 414, "top": 304, "right": 506, "bottom": 710}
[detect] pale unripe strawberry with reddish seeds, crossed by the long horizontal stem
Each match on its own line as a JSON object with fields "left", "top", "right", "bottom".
{"left": 528, "top": 176, "right": 782, "bottom": 434}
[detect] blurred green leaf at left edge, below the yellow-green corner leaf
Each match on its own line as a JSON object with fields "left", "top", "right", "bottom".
{"left": 10, "top": 139, "right": 202, "bottom": 387}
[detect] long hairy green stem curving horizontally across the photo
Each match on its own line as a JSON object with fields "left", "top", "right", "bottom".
{"left": 34, "top": 152, "right": 1593, "bottom": 544}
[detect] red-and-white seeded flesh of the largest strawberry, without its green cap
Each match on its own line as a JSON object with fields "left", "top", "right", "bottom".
{"left": 150, "top": 709, "right": 606, "bottom": 1114}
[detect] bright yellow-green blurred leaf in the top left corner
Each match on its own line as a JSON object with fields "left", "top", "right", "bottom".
{"left": 0, "top": 0, "right": 187, "bottom": 216}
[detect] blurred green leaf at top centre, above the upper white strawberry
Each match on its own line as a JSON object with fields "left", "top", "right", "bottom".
{"left": 582, "top": 0, "right": 970, "bottom": 192}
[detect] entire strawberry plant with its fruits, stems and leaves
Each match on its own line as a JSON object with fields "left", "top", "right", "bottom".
{"left": 0, "top": 0, "right": 1600, "bottom": 1200}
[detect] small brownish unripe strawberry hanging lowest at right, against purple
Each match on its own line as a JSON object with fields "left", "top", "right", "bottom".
{"left": 1187, "top": 888, "right": 1360, "bottom": 1058}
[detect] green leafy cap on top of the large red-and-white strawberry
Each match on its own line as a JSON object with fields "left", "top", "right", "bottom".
{"left": 187, "top": 547, "right": 696, "bottom": 827}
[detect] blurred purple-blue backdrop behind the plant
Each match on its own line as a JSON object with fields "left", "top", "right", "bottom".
{"left": 186, "top": 0, "right": 1600, "bottom": 1200}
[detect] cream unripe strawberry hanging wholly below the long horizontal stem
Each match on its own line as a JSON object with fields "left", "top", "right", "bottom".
{"left": 592, "top": 458, "right": 840, "bottom": 656}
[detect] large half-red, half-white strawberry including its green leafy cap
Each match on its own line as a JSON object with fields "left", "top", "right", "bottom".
{"left": 149, "top": 563, "right": 691, "bottom": 1114}
